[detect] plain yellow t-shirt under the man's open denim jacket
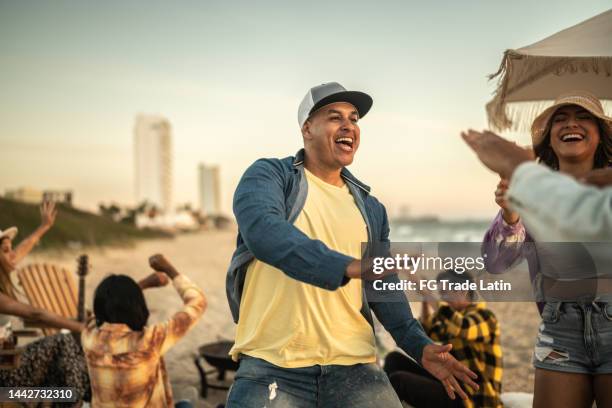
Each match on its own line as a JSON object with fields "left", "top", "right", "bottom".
{"left": 230, "top": 170, "right": 375, "bottom": 368}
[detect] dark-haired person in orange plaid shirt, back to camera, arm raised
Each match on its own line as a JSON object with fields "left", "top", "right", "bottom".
{"left": 81, "top": 255, "right": 206, "bottom": 407}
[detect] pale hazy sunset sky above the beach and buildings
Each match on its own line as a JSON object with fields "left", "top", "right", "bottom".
{"left": 0, "top": 0, "right": 610, "bottom": 218}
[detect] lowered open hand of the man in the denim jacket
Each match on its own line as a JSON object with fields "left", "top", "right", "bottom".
{"left": 421, "top": 344, "right": 479, "bottom": 400}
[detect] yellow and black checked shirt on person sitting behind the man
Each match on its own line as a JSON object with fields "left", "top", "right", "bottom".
{"left": 421, "top": 302, "right": 503, "bottom": 408}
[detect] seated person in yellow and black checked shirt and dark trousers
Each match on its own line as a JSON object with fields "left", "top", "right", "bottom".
{"left": 384, "top": 270, "right": 502, "bottom": 408}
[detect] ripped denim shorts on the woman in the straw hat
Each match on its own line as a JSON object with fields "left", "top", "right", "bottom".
{"left": 533, "top": 302, "right": 612, "bottom": 374}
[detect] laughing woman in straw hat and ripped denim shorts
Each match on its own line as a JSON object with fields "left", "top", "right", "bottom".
{"left": 483, "top": 91, "right": 612, "bottom": 408}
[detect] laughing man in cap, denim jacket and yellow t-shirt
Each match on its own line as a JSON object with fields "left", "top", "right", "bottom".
{"left": 227, "top": 82, "right": 478, "bottom": 408}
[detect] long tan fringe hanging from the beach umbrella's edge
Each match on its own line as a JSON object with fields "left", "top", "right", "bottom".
{"left": 486, "top": 50, "right": 612, "bottom": 131}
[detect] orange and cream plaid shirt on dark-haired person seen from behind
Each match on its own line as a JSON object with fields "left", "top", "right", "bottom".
{"left": 81, "top": 275, "right": 205, "bottom": 407}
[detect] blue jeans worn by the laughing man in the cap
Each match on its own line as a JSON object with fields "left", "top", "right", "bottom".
{"left": 227, "top": 355, "right": 402, "bottom": 408}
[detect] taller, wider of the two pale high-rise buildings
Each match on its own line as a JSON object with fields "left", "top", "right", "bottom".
{"left": 134, "top": 115, "right": 172, "bottom": 211}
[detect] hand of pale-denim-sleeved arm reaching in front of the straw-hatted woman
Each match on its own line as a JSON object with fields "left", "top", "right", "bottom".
{"left": 461, "top": 129, "right": 534, "bottom": 180}
